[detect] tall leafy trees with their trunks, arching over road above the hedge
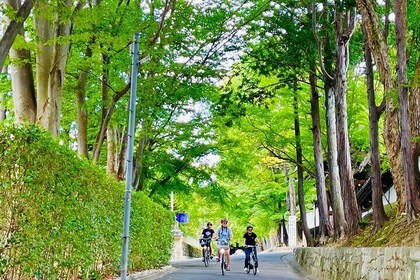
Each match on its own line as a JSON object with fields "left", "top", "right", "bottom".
{"left": 0, "top": 0, "right": 420, "bottom": 245}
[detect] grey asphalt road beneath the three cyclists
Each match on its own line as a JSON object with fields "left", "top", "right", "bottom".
{"left": 142, "top": 252, "right": 312, "bottom": 280}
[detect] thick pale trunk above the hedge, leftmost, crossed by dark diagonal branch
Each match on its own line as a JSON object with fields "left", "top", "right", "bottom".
{"left": 7, "top": 0, "right": 36, "bottom": 124}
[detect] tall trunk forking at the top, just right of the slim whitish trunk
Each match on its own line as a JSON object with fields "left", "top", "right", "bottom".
{"left": 335, "top": 5, "right": 360, "bottom": 235}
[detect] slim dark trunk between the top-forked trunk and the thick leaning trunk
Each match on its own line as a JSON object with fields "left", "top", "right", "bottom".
{"left": 363, "top": 28, "right": 388, "bottom": 232}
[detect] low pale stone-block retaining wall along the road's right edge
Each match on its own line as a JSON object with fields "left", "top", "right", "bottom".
{"left": 293, "top": 247, "right": 420, "bottom": 280}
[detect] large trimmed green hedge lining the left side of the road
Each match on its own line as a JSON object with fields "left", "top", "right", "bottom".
{"left": 0, "top": 125, "right": 173, "bottom": 279}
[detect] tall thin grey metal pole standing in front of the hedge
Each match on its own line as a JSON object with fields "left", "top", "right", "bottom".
{"left": 121, "top": 33, "right": 139, "bottom": 280}
